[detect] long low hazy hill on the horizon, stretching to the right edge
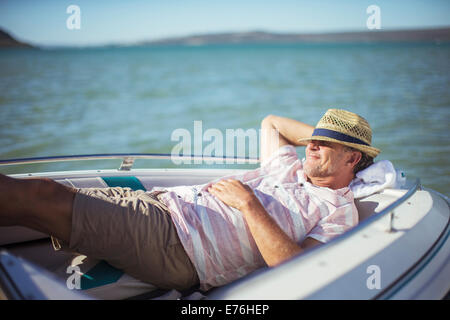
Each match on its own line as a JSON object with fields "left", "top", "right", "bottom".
{"left": 140, "top": 28, "right": 450, "bottom": 45}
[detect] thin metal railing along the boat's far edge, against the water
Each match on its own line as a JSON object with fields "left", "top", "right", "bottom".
{"left": 0, "top": 153, "right": 259, "bottom": 171}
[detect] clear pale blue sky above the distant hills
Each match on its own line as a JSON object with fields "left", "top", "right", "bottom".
{"left": 0, "top": 0, "right": 450, "bottom": 46}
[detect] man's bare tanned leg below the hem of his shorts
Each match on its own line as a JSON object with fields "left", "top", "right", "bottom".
{"left": 0, "top": 174, "right": 76, "bottom": 243}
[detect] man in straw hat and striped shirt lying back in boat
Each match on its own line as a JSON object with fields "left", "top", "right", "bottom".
{"left": 0, "top": 109, "right": 380, "bottom": 290}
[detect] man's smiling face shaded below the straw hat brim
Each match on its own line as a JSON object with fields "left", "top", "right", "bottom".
{"left": 303, "top": 140, "right": 348, "bottom": 178}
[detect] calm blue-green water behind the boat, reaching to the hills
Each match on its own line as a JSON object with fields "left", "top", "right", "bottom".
{"left": 0, "top": 44, "right": 450, "bottom": 195}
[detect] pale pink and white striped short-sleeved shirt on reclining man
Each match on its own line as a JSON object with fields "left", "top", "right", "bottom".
{"left": 156, "top": 145, "right": 358, "bottom": 290}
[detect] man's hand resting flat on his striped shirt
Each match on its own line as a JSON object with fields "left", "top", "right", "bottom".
{"left": 208, "top": 179, "right": 256, "bottom": 210}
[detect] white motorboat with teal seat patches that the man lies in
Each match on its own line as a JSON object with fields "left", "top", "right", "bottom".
{"left": 0, "top": 154, "right": 450, "bottom": 300}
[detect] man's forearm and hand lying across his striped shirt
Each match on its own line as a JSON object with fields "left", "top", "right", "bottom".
{"left": 208, "top": 179, "right": 321, "bottom": 267}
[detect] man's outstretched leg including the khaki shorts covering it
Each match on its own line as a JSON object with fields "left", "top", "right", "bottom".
{"left": 0, "top": 174, "right": 199, "bottom": 289}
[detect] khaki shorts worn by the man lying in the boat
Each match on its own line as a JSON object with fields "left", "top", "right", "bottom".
{"left": 62, "top": 187, "right": 199, "bottom": 290}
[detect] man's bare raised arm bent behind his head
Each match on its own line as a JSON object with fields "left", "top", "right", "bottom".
{"left": 260, "top": 115, "right": 314, "bottom": 162}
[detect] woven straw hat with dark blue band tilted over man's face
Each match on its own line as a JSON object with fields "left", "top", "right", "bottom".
{"left": 298, "top": 109, "right": 380, "bottom": 158}
